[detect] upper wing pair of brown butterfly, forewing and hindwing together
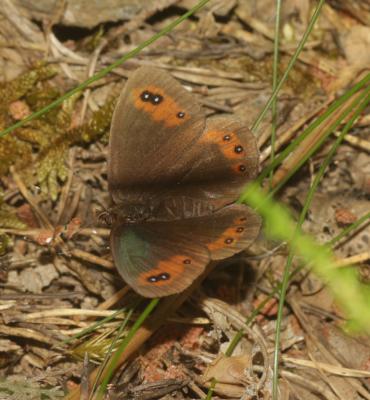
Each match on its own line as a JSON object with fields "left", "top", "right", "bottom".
{"left": 108, "top": 67, "right": 258, "bottom": 208}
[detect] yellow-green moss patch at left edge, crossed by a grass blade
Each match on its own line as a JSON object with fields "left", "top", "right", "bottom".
{"left": 0, "top": 65, "right": 118, "bottom": 200}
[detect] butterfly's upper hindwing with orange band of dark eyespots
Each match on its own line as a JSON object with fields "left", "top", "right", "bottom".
{"left": 178, "top": 116, "right": 259, "bottom": 208}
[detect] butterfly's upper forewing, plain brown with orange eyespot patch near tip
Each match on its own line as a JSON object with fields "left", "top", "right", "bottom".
{"left": 108, "top": 67, "right": 205, "bottom": 203}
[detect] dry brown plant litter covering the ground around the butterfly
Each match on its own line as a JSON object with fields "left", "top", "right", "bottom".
{"left": 0, "top": 0, "right": 370, "bottom": 400}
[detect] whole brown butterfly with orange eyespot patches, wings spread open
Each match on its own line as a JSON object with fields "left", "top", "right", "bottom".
{"left": 108, "top": 67, "right": 261, "bottom": 297}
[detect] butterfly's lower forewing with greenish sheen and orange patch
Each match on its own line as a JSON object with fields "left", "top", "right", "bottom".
{"left": 111, "top": 221, "right": 209, "bottom": 297}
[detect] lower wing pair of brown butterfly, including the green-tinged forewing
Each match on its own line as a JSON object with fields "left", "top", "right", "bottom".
{"left": 111, "top": 205, "right": 260, "bottom": 297}
